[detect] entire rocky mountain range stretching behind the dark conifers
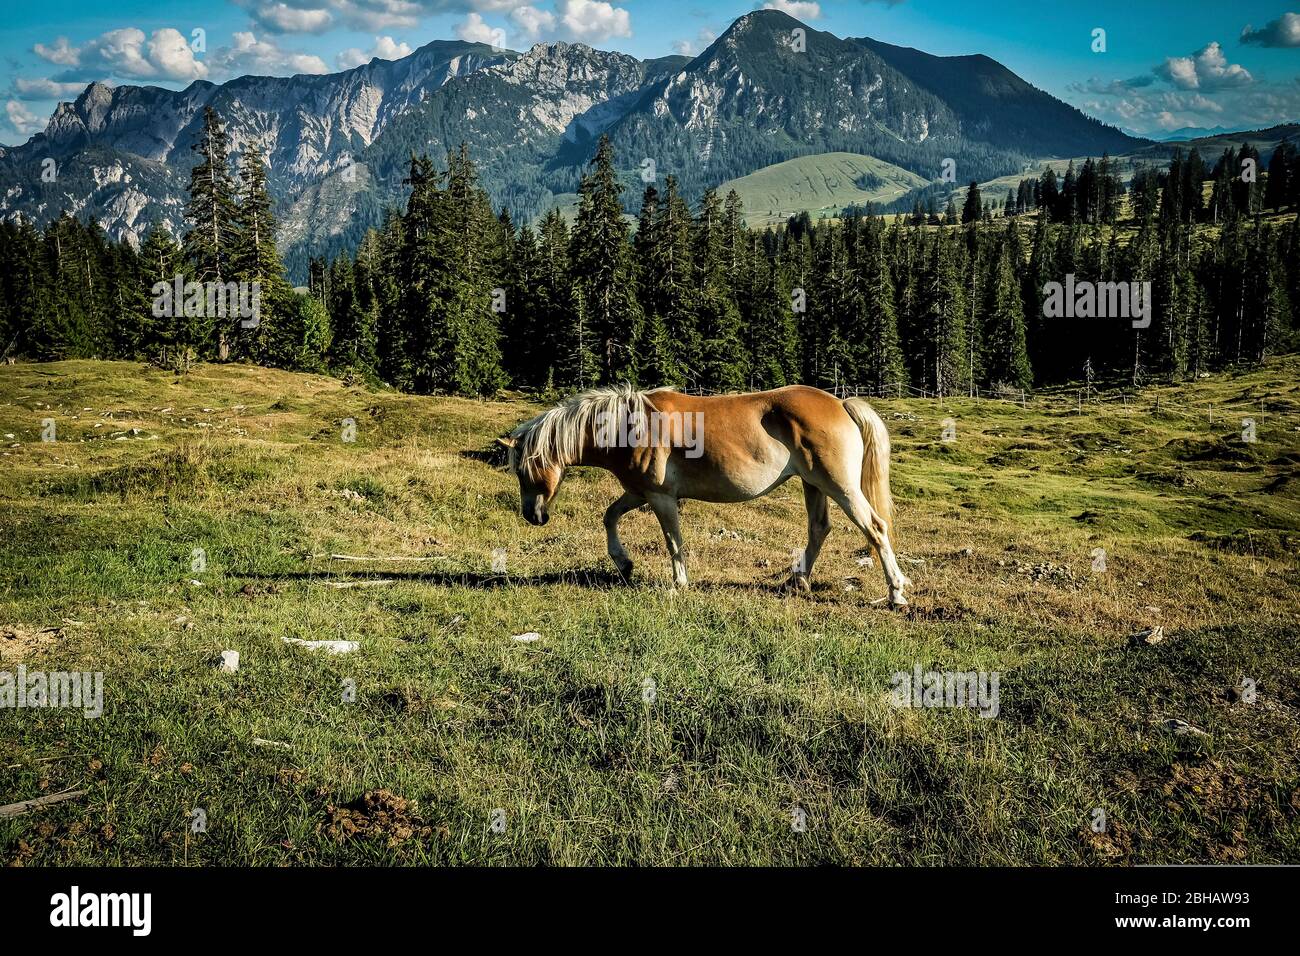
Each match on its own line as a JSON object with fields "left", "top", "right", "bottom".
{"left": 0, "top": 10, "right": 1145, "bottom": 278}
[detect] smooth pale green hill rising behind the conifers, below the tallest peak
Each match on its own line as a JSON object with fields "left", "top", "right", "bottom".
{"left": 718, "top": 152, "right": 926, "bottom": 228}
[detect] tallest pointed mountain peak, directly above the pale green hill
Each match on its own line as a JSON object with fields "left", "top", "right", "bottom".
{"left": 590, "top": 10, "right": 977, "bottom": 201}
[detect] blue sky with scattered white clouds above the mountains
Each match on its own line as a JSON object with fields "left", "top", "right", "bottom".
{"left": 0, "top": 0, "right": 1300, "bottom": 144}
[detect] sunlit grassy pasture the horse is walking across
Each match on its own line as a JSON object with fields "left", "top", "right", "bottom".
{"left": 0, "top": 358, "right": 1300, "bottom": 865}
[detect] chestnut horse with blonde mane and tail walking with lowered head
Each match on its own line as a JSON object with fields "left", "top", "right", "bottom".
{"left": 497, "top": 385, "right": 911, "bottom": 607}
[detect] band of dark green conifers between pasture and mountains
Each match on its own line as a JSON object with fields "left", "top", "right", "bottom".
{"left": 0, "top": 111, "right": 1300, "bottom": 395}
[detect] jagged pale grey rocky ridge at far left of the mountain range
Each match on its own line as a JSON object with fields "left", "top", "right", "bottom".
{"left": 0, "top": 40, "right": 506, "bottom": 251}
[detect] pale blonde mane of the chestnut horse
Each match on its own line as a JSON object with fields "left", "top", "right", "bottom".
{"left": 510, "top": 385, "right": 655, "bottom": 476}
